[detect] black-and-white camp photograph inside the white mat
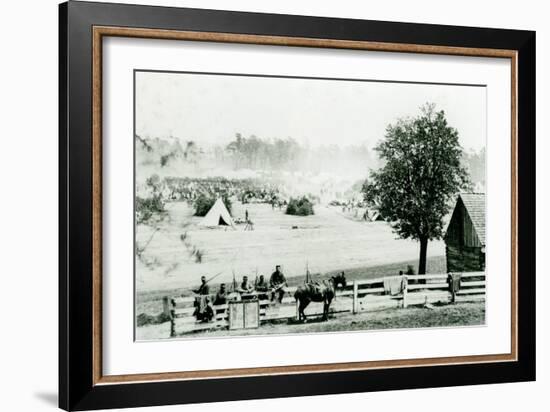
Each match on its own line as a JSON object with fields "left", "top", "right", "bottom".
{"left": 134, "top": 70, "right": 487, "bottom": 341}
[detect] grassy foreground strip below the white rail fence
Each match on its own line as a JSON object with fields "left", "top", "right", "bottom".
{"left": 136, "top": 301, "right": 485, "bottom": 340}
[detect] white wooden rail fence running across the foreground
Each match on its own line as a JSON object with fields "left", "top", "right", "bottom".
{"left": 163, "top": 272, "right": 485, "bottom": 336}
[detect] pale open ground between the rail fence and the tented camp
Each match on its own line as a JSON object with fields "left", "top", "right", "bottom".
{"left": 136, "top": 202, "right": 445, "bottom": 293}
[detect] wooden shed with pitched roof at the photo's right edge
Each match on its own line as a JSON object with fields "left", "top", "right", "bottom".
{"left": 445, "top": 193, "right": 485, "bottom": 272}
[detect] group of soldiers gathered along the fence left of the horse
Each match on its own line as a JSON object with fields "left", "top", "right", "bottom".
{"left": 193, "top": 265, "right": 287, "bottom": 322}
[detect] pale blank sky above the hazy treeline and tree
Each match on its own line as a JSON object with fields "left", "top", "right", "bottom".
{"left": 136, "top": 72, "right": 486, "bottom": 150}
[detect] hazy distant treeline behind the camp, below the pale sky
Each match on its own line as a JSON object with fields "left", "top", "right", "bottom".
{"left": 136, "top": 133, "right": 485, "bottom": 185}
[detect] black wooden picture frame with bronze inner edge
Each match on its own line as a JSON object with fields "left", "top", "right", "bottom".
{"left": 59, "top": 1, "right": 535, "bottom": 410}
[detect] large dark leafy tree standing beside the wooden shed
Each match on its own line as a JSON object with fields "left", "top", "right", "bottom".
{"left": 363, "top": 104, "right": 469, "bottom": 274}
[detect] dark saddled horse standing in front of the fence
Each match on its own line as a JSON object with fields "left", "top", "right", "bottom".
{"left": 294, "top": 272, "right": 346, "bottom": 322}
